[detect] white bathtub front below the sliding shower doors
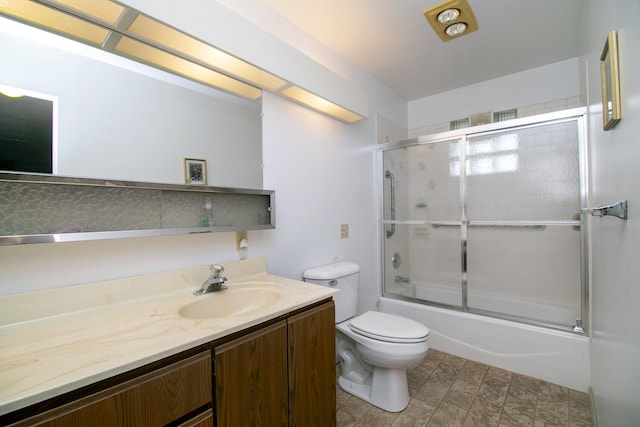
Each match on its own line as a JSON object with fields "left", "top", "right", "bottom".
{"left": 378, "top": 297, "right": 591, "bottom": 392}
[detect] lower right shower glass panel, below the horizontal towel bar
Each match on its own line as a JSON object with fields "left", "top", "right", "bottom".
{"left": 467, "top": 226, "right": 580, "bottom": 325}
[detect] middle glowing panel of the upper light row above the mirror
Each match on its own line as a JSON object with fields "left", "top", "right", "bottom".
{"left": 127, "top": 15, "right": 287, "bottom": 91}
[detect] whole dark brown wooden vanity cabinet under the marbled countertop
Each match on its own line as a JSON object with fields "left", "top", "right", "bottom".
{"left": 0, "top": 300, "right": 336, "bottom": 427}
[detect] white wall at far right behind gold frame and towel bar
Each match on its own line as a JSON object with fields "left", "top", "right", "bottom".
{"left": 584, "top": 0, "right": 640, "bottom": 426}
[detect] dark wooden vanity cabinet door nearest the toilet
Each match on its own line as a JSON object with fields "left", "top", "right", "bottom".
{"left": 288, "top": 301, "right": 336, "bottom": 427}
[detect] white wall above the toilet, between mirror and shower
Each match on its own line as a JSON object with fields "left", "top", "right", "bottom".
{"left": 262, "top": 94, "right": 379, "bottom": 308}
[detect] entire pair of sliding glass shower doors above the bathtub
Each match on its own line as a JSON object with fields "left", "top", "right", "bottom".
{"left": 382, "top": 109, "right": 586, "bottom": 330}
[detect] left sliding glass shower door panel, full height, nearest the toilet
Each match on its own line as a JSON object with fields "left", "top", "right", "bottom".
{"left": 384, "top": 140, "right": 462, "bottom": 307}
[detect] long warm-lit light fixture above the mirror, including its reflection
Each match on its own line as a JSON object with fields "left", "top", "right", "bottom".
{"left": 0, "top": 0, "right": 365, "bottom": 123}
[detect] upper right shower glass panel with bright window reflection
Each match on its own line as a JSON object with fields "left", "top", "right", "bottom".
{"left": 467, "top": 122, "right": 580, "bottom": 221}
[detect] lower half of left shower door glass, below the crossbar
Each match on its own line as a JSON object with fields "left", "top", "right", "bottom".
{"left": 384, "top": 224, "right": 462, "bottom": 307}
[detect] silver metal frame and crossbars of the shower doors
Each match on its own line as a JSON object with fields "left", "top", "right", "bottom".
{"left": 378, "top": 108, "right": 589, "bottom": 334}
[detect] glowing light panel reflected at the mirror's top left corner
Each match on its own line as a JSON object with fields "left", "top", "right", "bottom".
{"left": 0, "top": 0, "right": 109, "bottom": 45}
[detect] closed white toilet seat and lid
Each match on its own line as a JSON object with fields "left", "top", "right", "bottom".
{"left": 349, "top": 311, "right": 429, "bottom": 343}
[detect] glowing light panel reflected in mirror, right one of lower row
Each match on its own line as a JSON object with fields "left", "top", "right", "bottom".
{"left": 115, "top": 37, "right": 262, "bottom": 100}
